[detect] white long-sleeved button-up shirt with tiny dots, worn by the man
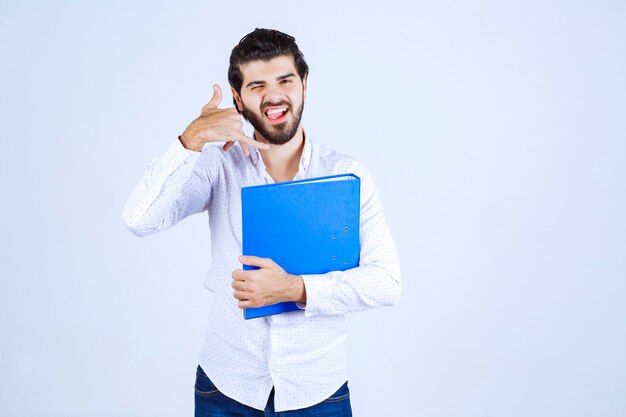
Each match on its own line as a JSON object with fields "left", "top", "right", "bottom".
{"left": 122, "top": 135, "right": 401, "bottom": 411}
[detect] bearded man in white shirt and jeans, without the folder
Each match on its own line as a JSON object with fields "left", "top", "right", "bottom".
{"left": 122, "top": 29, "right": 401, "bottom": 416}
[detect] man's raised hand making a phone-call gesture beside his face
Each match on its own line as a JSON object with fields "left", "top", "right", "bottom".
{"left": 180, "top": 84, "right": 270, "bottom": 156}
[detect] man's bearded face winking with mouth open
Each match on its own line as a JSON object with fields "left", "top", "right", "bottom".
{"left": 231, "top": 56, "right": 306, "bottom": 145}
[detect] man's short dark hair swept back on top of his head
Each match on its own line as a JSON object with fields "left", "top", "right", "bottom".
{"left": 228, "top": 28, "right": 309, "bottom": 108}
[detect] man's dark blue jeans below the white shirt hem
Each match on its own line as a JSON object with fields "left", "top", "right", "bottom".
{"left": 194, "top": 365, "right": 352, "bottom": 417}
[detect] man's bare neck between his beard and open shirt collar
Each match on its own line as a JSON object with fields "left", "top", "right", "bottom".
{"left": 254, "top": 126, "right": 304, "bottom": 182}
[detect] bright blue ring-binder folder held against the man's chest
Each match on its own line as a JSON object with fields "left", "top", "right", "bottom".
{"left": 241, "top": 174, "right": 361, "bottom": 319}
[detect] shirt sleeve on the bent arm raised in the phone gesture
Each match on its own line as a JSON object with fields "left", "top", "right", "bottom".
{"left": 122, "top": 139, "right": 211, "bottom": 236}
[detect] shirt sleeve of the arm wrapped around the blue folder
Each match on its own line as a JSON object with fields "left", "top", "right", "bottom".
{"left": 297, "top": 162, "right": 401, "bottom": 317}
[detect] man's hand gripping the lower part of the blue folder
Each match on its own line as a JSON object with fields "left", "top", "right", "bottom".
{"left": 231, "top": 256, "right": 306, "bottom": 308}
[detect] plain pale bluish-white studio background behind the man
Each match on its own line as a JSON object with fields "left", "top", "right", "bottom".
{"left": 0, "top": 0, "right": 626, "bottom": 417}
